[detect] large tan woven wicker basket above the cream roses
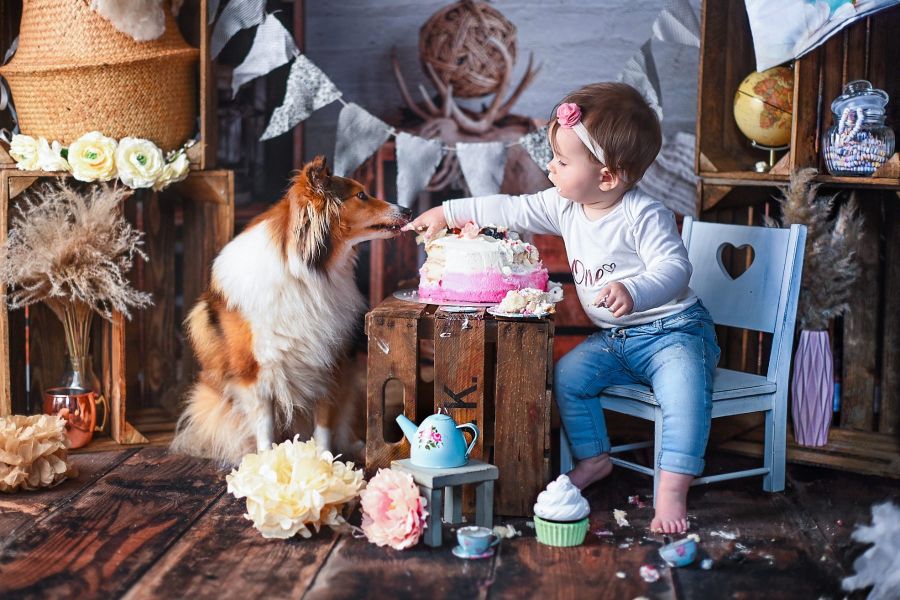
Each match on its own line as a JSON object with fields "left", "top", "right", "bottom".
{"left": 0, "top": 0, "right": 199, "bottom": 150}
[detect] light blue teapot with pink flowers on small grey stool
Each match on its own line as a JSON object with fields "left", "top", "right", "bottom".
{"left": 397, "top": 412, "right": 478, "bottom": 469}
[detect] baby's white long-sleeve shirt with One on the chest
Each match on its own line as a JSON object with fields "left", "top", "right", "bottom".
{"left": 444, "top": 188, "right": 697, "bottom": 328}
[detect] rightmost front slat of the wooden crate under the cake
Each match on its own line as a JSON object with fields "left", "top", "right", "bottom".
{"left": 494, "top": 321, "right": 550, "bottom": 515}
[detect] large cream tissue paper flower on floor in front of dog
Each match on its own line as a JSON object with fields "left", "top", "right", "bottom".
{"left": 225, "top": 436, "right": 365, "bottom": 538}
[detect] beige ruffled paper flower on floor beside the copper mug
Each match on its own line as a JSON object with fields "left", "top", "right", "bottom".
{"left": 0, "top": 415, "right": 77, "bottom": 493}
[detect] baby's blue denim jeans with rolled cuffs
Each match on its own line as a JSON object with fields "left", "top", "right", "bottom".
{"left": 554, "top": 301, "right": 719, "bottom": 475}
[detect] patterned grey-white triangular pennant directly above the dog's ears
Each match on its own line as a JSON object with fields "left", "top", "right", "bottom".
{"left": 259, "top": 54, "right": 341, "bottom": 141}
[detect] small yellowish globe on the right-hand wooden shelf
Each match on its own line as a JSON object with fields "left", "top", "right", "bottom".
{"left": 734, "top": 67, "right": 794, "bottom": 147}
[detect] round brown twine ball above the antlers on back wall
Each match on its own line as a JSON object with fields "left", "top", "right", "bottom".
{"left": 419, "top": 0, "right": 516, "bottom": 98}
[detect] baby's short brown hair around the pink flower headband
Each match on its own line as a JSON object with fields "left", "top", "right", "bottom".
{"left": 549, "top": 82, "right": 662, "bottom": 188}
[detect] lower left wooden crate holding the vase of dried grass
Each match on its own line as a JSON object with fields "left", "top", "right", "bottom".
{"left": 0, "top": 169, "right": 234, "bottom": 450}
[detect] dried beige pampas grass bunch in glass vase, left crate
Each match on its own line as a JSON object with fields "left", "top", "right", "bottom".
{"left": 0, "top": 182, "right": 152, "bottom": 357}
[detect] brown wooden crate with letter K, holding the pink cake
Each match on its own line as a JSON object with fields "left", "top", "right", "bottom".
{"left": 366, "top": 297, "right": 553, "bottom": 516}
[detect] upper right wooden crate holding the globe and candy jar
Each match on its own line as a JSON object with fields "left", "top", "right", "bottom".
{"left": 695, "top": 0, "right": 900, "bottom": 188}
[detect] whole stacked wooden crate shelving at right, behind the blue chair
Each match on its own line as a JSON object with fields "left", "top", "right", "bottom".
{"left": 695, "top": 0, "right": 900, "bottom": 478}
